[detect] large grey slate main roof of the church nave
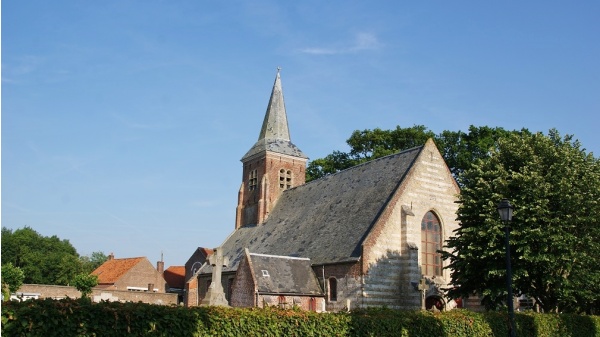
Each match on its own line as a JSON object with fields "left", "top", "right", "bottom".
{"left": 213, "top": 146, "right": 423, "bottom": 272}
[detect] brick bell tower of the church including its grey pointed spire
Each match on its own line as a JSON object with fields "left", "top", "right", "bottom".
{"left": 235, "top": 68, "right": 308, "bottom": 229}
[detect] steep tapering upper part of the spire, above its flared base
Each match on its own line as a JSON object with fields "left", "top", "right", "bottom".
{"left": 258, "top": 67, "right": 290, "bottom": 141}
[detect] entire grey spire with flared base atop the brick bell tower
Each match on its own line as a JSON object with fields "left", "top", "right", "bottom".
{"left": 242, "top": 67, "right": 308, "bottom": 161}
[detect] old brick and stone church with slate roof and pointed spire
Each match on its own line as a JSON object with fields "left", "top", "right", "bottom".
{"left": 188, "top": 71, "right": 461, "bottom": 311}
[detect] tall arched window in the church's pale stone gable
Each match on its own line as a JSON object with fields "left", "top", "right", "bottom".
{"left": 421, "top": 211, "right": 442, "bottom": 276}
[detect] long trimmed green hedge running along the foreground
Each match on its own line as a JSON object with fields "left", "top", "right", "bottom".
{"left": 2, "top": 299, "right": 600, "bottom": 337}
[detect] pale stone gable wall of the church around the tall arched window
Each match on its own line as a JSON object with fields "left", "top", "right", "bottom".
{"left": 362, "top": 142, "right": 459, "bottom": 309}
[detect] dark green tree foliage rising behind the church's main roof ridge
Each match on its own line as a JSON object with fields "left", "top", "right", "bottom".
{"left": 306, "top": 125, "right": 530, "bottom": 181}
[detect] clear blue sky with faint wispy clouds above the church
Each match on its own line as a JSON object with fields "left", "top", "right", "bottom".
{"left": 2, "top": 0, "right": 600, "bottom": 265}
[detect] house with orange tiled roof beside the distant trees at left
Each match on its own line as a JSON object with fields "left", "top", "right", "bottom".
{"left": 92, "top": 253, "right": 167, "bottom": 293}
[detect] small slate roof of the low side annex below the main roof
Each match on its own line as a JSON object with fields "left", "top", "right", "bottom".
{"left": 249, "top": 253, "right": 323, "bottom": 295}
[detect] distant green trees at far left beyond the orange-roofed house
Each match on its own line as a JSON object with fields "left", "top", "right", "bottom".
{"left": 2, "top": 227, "right": 106, "bottom": 285}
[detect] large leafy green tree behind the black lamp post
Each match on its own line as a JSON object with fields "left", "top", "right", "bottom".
{"left": 442, "top": 130, "right": 600, "bottom": 312}
